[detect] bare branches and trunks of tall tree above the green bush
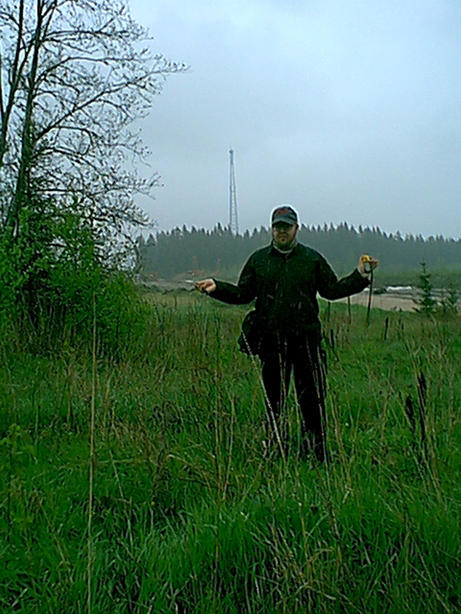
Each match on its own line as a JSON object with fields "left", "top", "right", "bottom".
{"left": 0, "top": 0, "right": 185, "bottom": 258}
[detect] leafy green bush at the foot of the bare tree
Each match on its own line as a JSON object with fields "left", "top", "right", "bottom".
{"left": 0, "top": 192, "right": 153, "bottom": 355}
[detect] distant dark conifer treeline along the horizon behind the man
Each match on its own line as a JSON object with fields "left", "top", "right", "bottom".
{"left": 137, "top": 223, "right": 461, "bottom": 278}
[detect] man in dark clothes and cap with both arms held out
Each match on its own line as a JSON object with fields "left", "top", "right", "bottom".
{"left": 196, "top": 205, "right": 378, "bottom": 461}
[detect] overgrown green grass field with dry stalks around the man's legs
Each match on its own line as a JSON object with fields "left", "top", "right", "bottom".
{"left": 0, "top": 295, "right": 461, "bottom": 614}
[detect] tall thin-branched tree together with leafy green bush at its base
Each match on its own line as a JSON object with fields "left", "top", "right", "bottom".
{"left": 0, "top": 0, "right": 186, "bottom": 352}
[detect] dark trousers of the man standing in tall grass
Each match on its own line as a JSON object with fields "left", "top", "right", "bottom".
{"left": 260, "top": 335, "right": 326, "bottom": 461}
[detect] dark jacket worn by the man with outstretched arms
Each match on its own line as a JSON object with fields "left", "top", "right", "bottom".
{"left": 210, "top": 243, "right": 369, "bottom": 333}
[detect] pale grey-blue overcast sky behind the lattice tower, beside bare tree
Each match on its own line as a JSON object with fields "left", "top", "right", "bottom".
{"left": 129, "top": 0, "right": 461, "bottom": 238}
